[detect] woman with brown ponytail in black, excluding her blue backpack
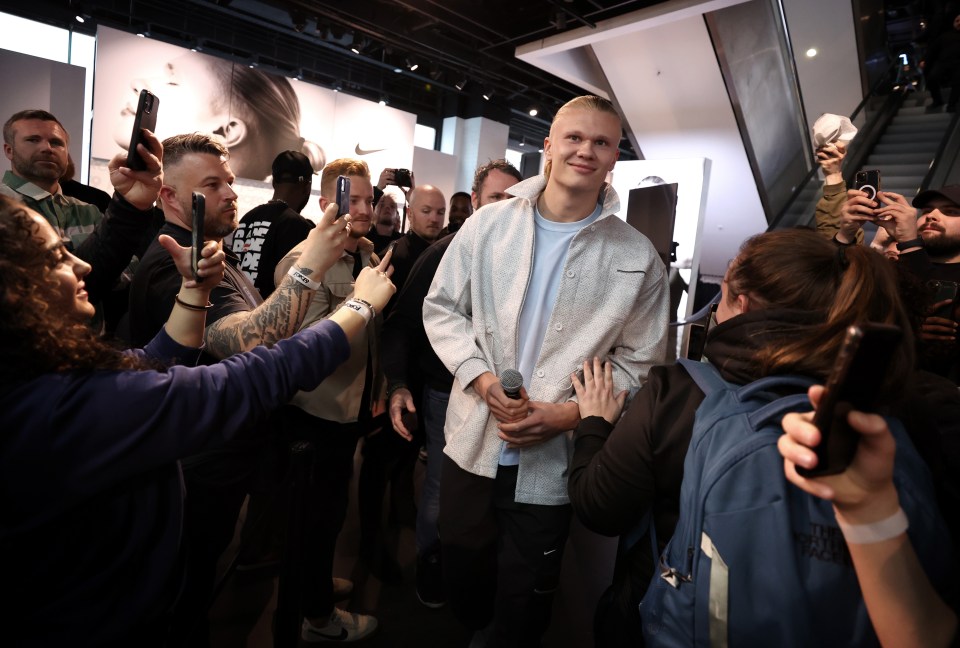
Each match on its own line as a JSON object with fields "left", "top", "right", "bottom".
{"left": 568, "top": 230, "right": 956, "bottom": 648}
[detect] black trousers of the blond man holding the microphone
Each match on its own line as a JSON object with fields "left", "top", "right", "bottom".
{"left": 440, "top": 456, "right": 571, "bottom": 648}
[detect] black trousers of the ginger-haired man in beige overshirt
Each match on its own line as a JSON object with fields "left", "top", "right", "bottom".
{"left": 283, "top": 405, "right": 361, "bottom": 618}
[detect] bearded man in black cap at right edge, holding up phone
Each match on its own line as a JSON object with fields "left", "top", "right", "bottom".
{"left": 843, "top": 185, "right": 960, "bottom": 384}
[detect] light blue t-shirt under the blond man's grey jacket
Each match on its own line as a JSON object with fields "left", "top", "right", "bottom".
{"left": 500, "top": 203, "right": 601, "bottom": 466}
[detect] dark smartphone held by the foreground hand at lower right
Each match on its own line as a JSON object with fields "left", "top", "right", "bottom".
{"left": 797, "top": 323, "right": 903, "bottom": 477}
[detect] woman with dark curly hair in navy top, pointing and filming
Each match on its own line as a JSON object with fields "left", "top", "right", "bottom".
{"left": 0, "top": 198, "right": 394, "bottom": 646}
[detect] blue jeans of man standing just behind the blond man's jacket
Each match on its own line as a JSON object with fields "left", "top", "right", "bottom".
{"left": 417, "top": 387, "right": 450, "bottom": 556}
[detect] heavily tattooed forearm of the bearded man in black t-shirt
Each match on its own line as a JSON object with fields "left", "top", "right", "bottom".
{"left": 205, "top": 270, "right": 314, "bottom": 358}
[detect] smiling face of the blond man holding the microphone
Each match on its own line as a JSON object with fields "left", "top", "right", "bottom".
{"left": 543, "top": 108, "right": 620, "bottom": 194}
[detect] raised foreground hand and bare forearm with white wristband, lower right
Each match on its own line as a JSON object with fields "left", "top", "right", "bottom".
{"left": 777, "top": 386, "right": 957, "bottom": 648}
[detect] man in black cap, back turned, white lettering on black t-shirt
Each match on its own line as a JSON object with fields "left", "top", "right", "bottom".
{"left": 233, "top": 151, "right": 314, "bottom": 299}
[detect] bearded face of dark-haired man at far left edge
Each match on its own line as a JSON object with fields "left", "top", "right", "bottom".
{"left": 3, "top": 119, "right": 69, "bottom": 190}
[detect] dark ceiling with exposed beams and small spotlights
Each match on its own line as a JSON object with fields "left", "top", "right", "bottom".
{"left": 0, "top": 0, "right": 659, "bottom": 159}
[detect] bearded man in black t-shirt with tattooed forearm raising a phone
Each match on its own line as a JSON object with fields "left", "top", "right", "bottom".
{"left": 124, "top": 133, "right": 350, "bottom": 643}
